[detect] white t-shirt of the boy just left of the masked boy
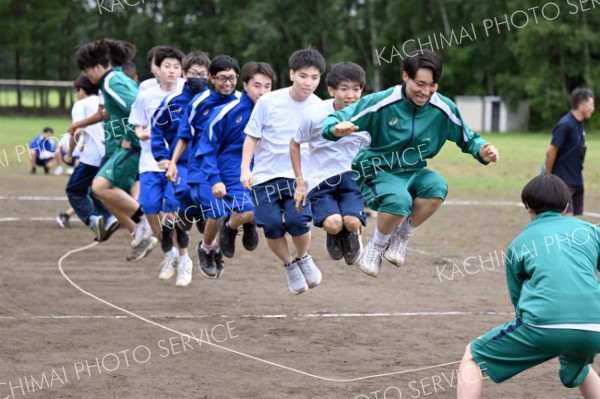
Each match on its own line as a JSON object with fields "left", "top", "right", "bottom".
{"left": 129, "top": 79, "right": 185, "bottom": 173}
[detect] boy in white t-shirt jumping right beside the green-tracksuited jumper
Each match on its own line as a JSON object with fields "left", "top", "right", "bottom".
{"left": 290, "top": 62, "right": 371, "bottom": 265}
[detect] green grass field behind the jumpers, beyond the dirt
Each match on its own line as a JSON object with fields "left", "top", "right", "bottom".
{"left": 0, "top": 117, "right": 600, "bottom": 199}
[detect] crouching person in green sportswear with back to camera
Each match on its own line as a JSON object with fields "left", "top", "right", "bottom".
{"left": 458, "top": 175, "right": 600, "bottom": 399}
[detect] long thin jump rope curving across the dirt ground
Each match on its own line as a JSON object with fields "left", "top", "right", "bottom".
{"left": 58, "top": 242, "right": 460, "bottom": 382}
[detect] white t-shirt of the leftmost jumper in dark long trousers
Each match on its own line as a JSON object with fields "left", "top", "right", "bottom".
{"left": 71, "top": 95, "right": 105, "bottom": 166}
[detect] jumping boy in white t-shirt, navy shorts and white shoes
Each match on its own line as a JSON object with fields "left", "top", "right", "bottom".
{"left": 240, "top": 48, "right": 325, "bottom": 294}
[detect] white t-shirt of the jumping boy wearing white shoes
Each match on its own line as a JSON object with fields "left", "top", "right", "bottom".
{"left": 244, "top": 87, "right": 321, "bottom": 184}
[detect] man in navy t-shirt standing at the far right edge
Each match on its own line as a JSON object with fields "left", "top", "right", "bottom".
{"left": 544, "top": 89, "right": 594, "bottom": 215}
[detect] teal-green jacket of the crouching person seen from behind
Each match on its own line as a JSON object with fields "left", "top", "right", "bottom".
{"left": 506, "top": 211, "right": 600, "bottom": 326}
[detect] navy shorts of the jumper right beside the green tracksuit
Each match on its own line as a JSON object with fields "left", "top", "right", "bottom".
{"left": 308, "top": 172, "right": 367, "bottom": 227}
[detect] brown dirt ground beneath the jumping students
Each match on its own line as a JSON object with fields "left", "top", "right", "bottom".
{"left": 0, "top": 167, "right": 600, "bottom": 399}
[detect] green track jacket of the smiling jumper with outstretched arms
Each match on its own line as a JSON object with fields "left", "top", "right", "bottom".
{"left": 321, "top": 85, "right": 487, "bottom": 184}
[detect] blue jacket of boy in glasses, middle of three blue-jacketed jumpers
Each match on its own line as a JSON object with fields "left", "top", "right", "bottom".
{"left": 177, "top": 89, "right": 241, "bottom": 184}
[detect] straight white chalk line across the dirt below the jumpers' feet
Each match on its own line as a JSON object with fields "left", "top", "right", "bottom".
{"left": 0, "top": 312, "right": 515, "bottom": 321}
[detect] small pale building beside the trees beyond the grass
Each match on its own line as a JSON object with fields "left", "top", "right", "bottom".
{"left": 455, "top": 96, "right": 529, "bottom": 133}
